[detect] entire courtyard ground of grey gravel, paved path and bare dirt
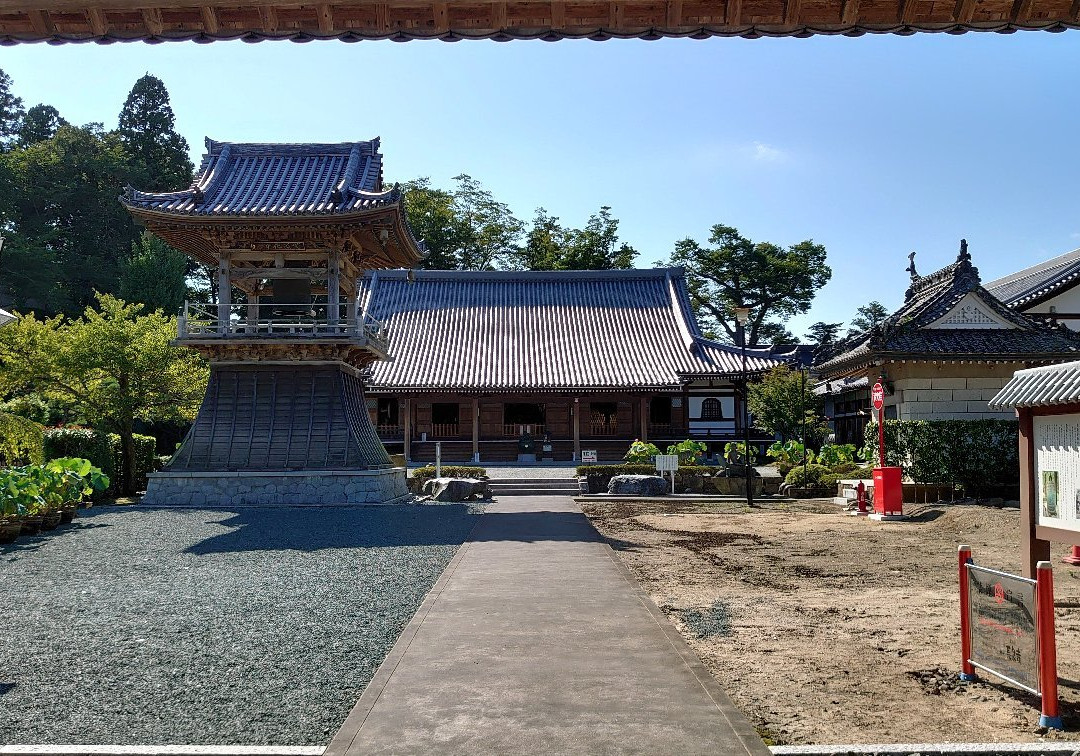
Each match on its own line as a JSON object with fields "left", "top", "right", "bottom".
{"left": 6, "top": 496, "right": 1080, "bottom": 756}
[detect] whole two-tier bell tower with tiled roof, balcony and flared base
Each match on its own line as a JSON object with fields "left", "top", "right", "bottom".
{"left": 121, "top": 139, "right": 423, "bottom": 505}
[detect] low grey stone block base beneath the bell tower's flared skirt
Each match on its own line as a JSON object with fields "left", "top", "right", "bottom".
{"left": 143, "top": 468, "right": 409, "bottom": 507}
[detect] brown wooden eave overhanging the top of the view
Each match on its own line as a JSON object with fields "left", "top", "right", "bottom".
{"left": 0, "top": 0, "right": 1080, "bottom": 44}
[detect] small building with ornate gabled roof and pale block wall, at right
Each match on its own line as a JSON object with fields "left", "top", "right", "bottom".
{"left": 815, "top": 241, "right": 1080, "bottom": 441}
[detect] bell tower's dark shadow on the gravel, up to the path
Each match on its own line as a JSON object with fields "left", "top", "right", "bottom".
{"left": 186, "top": 504, "right": 481, "bottom": 554}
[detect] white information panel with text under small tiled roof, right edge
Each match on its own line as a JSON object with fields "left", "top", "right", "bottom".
{"left": 1031, "top": 415, "right": 1080, "bottom": 530}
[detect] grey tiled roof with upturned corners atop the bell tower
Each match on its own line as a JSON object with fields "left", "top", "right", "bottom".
{"left": 121, "top": 138, "right": 402, "bottom": 217}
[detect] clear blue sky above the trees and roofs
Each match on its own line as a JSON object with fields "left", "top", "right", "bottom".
{"left": 0, "top": 32, "right": 1080, "bottom": 334}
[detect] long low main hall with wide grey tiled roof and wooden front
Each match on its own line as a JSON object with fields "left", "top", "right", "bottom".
{"left": 361, "top": 268, "right": 787, "bottom": 462}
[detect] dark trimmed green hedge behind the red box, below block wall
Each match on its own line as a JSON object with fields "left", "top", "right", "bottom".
{"left": 864, "top": 420, "right": 1020, "bottom": 496}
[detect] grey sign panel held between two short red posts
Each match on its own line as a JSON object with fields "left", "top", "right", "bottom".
{"left": 968, "top": 564, "right": 1039, "bottom": 694}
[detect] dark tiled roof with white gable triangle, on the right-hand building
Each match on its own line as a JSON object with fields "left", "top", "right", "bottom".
{"left": 818, "top": 238, "right": 1080, "bottom": 376}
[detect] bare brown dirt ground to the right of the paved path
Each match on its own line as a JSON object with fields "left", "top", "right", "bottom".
{"left": 582, "top": 501, "right": 1080, "bottom": 745}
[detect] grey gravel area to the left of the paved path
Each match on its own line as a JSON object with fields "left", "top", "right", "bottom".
{"left": 0, "top": 505, "right": 477, "bottom": 745}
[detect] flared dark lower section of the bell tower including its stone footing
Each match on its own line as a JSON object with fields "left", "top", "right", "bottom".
{"left": 144, "top": 361, "right": 408, "bottom": 507}
